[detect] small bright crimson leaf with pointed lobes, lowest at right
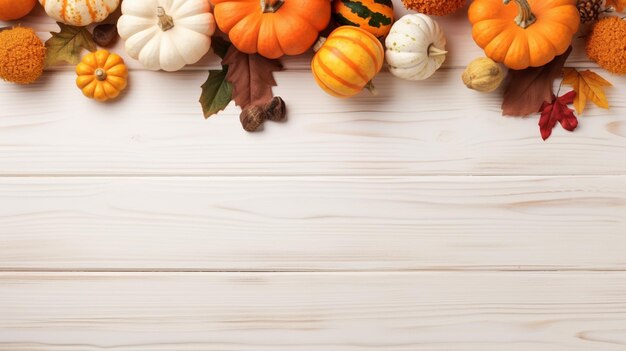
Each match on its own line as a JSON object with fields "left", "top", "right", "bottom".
{"left": 539, "top": 90, "right": 578, "bottom": 140}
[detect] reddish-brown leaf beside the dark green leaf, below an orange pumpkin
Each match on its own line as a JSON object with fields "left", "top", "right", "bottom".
{"left": 222, "top": 45, "right": 282, "bottom": 108}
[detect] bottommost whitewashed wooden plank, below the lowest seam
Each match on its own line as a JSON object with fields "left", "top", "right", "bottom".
{"left": 0, "top": 272, "right": 626, "bottom": 351}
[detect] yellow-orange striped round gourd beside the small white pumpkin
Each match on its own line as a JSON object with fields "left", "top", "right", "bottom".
{"left": 311, "top": 26, "right": 385, "bottom": 98}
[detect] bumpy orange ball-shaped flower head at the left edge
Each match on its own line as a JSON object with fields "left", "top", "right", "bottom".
{"left": 0, "top": 27, "right": 46, "bottom": 84}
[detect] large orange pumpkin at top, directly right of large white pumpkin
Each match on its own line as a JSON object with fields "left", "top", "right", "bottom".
{"left": 211, "top": 0, "right": 330, "bottom": 58}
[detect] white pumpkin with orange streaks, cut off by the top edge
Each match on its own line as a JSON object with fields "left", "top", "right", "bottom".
{"left": 39, "top": 0, "right": 120, "bottom": 26}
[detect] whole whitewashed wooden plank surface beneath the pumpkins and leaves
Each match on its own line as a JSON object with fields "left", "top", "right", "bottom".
{"left": 0, "top": 1, "right": 626, "bottom": 351}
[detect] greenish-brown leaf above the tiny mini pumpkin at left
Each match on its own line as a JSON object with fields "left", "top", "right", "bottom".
{"left": 45, "top": 22, "right": 98, "bottom": 67}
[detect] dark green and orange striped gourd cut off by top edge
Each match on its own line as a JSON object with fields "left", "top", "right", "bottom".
{"left": 333, "top": 0, "right": 393, "bottom": 38}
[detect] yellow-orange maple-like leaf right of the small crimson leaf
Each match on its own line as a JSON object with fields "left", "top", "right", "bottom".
{"left": 563, "top": 67, "right": 612, "bottom": 115}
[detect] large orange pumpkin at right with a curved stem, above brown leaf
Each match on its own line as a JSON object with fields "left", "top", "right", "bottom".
{"left": 468, "top": 0, "right": 580, "bottom": 69}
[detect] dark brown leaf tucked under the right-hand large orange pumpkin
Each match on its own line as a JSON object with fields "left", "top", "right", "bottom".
{"left": 502, "top": 46, "right": 572, "bottom": 116}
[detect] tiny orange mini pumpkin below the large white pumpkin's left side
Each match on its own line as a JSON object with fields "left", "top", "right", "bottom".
{"left": 76, "top": 50, "right": 128, "bottom": 101}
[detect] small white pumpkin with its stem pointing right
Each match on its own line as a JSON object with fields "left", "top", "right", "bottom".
{"left": 385, "top": 13, "right": 448, "bottom": 80}
